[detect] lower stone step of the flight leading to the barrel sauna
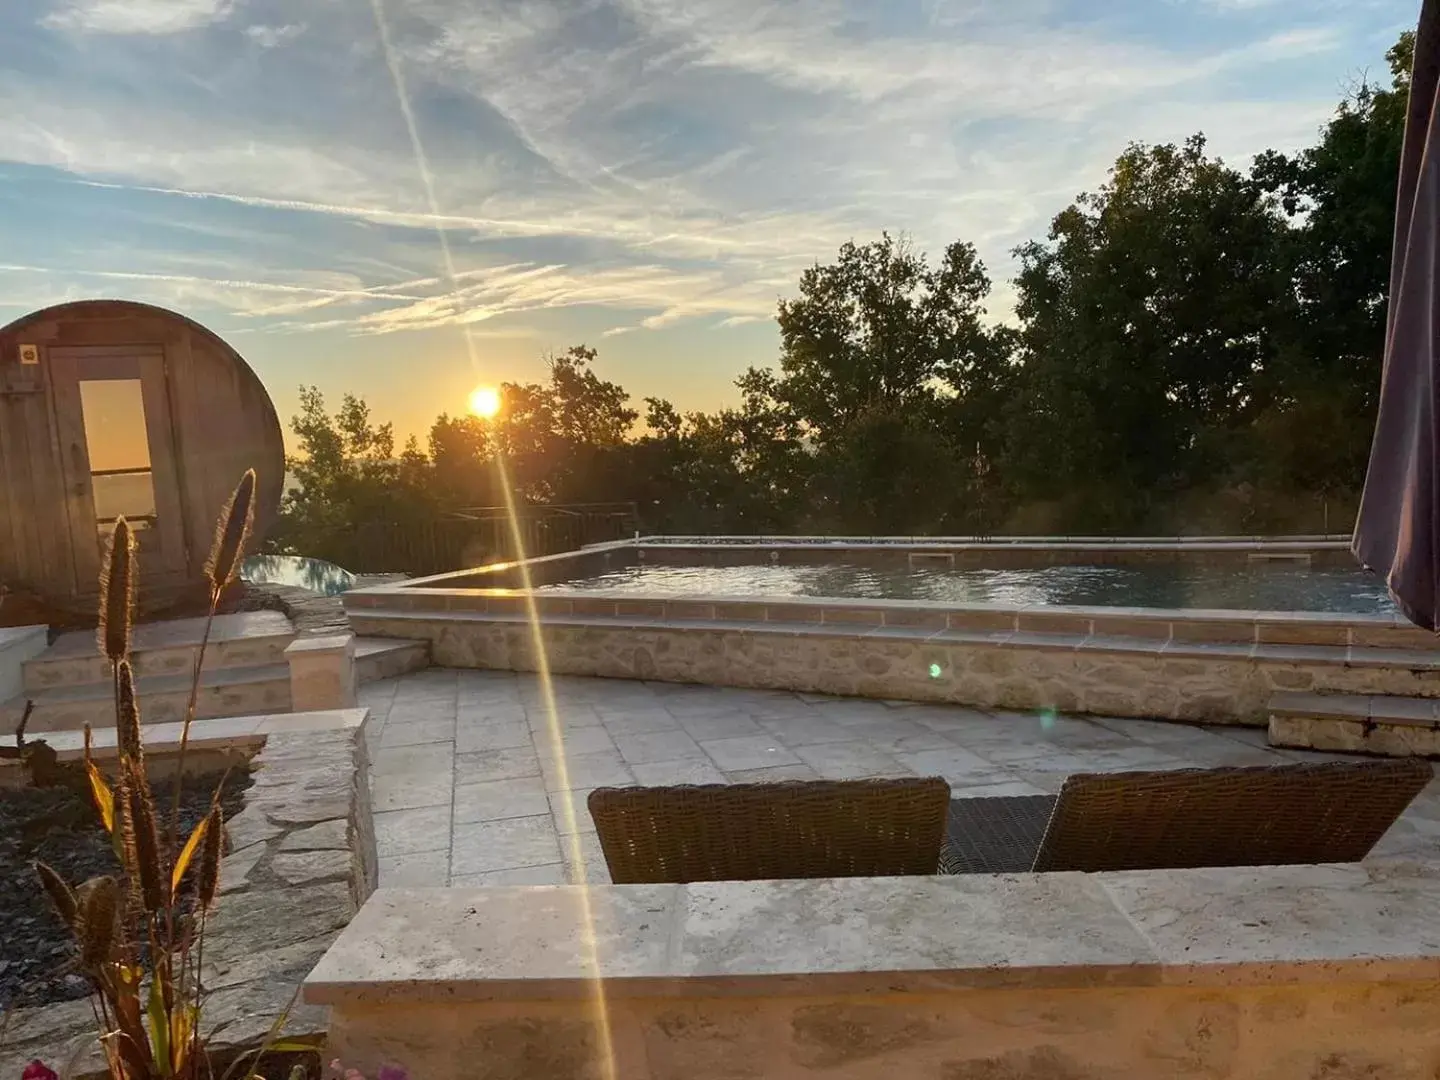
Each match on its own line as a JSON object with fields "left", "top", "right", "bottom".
{"left": 0, "top": 664, "right": 289, "bottom": 734}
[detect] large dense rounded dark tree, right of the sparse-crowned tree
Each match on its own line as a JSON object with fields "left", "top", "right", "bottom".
{"left": 1005, "top": 135, "right": 1293, "bottom": 527}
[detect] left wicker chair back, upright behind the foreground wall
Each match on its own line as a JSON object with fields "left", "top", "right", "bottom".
{"left": 589, "top": 776, "right": 950, "bottom": 884}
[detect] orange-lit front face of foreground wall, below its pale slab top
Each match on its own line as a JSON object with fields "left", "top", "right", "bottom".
{"left": 331, "top": 982, "right": 1440, "bottom": 1080}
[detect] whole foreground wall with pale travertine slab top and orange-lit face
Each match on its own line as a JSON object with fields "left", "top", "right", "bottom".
{"left": 305, "top": 864, "right": 1440, "bottom": 1080}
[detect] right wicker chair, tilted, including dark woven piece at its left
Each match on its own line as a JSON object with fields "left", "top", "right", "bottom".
{"left": 946, "top": 757, "right": 1433, "bottom": 874}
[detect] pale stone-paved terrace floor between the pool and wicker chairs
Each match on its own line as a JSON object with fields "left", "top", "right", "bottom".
{"left": 351, "top": 668, "right": 1440, "bottom": 886}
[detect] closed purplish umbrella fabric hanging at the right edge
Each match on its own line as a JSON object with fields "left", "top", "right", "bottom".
{"left": 1352, "top": 0, "right": 1440, "bottom": 631}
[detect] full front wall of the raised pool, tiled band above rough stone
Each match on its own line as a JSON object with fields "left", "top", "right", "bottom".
{"left": 346, "top": 588, "right": 1440, "bottom": 726}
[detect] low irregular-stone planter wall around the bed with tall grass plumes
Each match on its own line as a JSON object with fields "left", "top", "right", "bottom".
{"left": 0, "top": 708, "right": 377, "bottom": 1079}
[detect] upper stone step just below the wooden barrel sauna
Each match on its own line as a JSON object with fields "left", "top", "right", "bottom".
{"left": 24, "top": 611, "right": 295, "bottom": 696}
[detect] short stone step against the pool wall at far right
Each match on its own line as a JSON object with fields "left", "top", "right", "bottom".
{"left": 1269, "top": 693, "right": 1440, "bottom": 757}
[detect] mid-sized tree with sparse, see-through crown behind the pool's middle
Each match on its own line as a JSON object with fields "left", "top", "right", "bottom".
{"left": 771, "top": 233, "right": 1004, "bottom": 531}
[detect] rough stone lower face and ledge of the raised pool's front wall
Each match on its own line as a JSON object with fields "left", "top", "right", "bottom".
{"left": 339, "top": 608, "right": 1440, "bottom": 726}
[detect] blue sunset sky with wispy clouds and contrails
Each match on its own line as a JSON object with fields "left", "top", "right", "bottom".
{"left": 0, "top": 0, "right": 1418, "bottom": 449}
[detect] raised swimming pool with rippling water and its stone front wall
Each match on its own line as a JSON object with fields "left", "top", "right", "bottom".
{"left": 343, "top": 537, "right": 1440, "bottom": 724}
